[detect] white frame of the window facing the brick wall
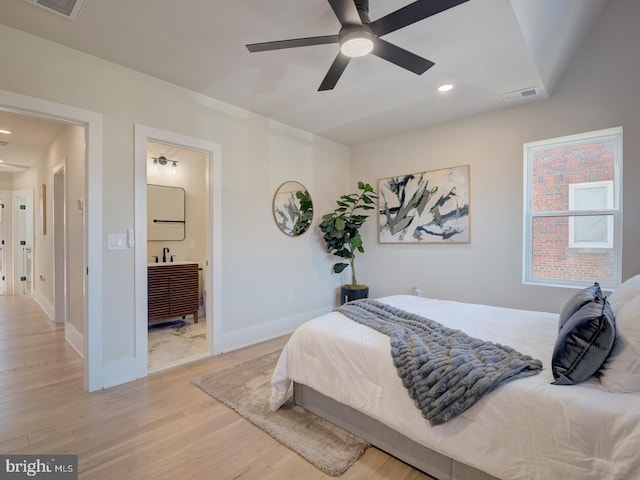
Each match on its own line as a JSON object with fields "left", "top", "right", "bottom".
{"left": 522, "top": 127, "right": 622, "bottom": 289}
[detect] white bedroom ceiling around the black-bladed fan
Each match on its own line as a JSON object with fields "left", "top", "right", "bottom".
{"left": 0, "top": 0, "right": 609, "bottom": 169}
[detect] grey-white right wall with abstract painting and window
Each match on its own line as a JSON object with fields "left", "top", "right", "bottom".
{"left": 351, "top": 0, "right": 640, "bottom": 311}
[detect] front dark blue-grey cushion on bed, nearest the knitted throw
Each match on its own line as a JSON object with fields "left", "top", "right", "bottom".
{"left": 551, "top": 299, "right": 616, "bottom": 385}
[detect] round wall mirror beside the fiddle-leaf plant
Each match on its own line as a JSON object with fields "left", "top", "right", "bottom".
{"left": 273, "top": 181, "right": 313, "bottom": 237}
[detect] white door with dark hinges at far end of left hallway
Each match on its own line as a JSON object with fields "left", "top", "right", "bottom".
{"left": 12, "top": 190, "right": 33, "bottom": 295}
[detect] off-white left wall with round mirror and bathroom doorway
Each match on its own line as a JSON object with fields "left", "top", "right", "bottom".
{"left": 0, "top": 25, "right": 349, "bottom": 385}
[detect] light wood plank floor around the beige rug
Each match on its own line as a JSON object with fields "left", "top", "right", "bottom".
{"left": 0, "top": 296, "right": 430, "bottom": 480}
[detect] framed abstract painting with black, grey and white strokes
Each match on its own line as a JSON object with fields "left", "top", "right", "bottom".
{"left": 378, "top": 165, "right": 471, "bottom": 243}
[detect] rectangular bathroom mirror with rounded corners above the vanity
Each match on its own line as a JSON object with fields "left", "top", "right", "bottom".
{"left": 147, "top": 184, "right": 185, "bottom": 240}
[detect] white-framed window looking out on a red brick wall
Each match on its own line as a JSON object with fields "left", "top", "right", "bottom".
{"left": 523, "top": 128, "right": 622, "bottom": 288}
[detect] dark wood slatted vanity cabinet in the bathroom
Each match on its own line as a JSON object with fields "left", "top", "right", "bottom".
{"left": 147, "top": 263, "right": 200, "bottom": 323}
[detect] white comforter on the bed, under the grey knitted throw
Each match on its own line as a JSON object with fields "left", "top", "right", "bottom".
{"left": 271, "top": 295, "right": 640, "bottom": 480}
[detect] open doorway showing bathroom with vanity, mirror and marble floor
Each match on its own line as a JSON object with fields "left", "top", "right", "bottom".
{"left": 147, "top": 141, "right": 209, "bottom": 372}
